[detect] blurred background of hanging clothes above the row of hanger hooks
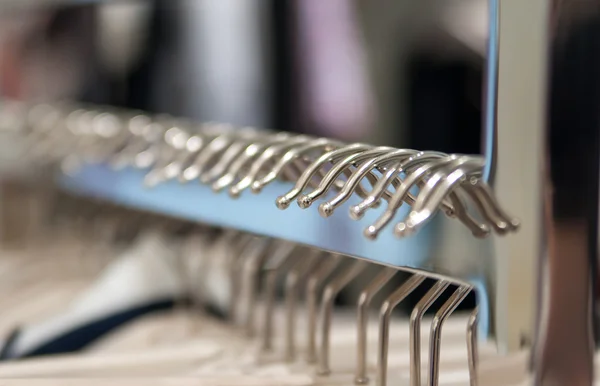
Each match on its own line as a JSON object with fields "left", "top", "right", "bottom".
{"left": 0, "top": 0, "right": 487, "bottom": 153}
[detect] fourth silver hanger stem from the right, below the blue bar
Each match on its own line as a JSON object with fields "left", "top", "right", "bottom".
{"left": 377, "top": 275, "right": 425, "bottom": 386}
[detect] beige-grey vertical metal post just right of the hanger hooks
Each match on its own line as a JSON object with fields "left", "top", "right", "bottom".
{"left": 485, "top": 0, "right": 548, "bottom": 352}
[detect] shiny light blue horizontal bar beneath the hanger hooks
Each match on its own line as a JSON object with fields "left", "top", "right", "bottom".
{"left": 60, "top": 165, "right": 489, "bottom": 337}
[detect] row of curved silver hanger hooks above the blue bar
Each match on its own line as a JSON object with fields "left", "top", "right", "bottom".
{"left": 3, "top": 99, "right": 519, "bottom": 239}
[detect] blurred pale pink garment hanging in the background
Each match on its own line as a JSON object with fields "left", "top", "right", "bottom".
{"left": 295, "top": 0, "right": 373, "bottom": 140}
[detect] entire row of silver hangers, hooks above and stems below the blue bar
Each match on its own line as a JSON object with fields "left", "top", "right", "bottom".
{"left": 0, "top": 103, "right": 519, "bottom": 385}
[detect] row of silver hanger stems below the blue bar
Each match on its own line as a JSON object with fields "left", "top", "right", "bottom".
{"left": 0, "top": 194, "right": 524, "bottom": 385}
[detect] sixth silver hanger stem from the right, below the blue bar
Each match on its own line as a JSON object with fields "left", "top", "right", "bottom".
{"left": 317, "top": 260, "right": 368, "bottom": 375}
